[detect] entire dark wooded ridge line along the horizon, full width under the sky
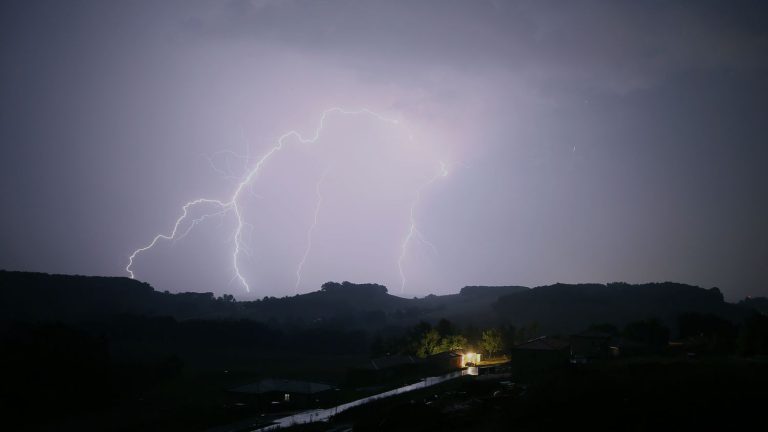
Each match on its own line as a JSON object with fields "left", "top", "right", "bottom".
{"left": 0, "top": 271, "right": 763, "bottom": 333}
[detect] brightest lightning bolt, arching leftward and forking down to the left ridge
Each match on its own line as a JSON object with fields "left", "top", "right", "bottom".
{"left": 125, "top": 107, "right": 420, "bottom": 292}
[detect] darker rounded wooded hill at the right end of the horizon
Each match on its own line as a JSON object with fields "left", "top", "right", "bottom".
{"left": 494, "top": 282, "right": 747, "bottom": 333}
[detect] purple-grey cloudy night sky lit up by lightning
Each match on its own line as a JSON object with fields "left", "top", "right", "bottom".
{"left": 0, "top": 0, "right": 768, "bottom": 300}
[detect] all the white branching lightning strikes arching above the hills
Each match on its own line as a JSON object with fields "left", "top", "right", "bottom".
{"left": 125, "top": 107, "right": 448, "bottom": 292}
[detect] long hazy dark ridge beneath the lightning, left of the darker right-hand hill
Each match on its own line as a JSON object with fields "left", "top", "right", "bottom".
{"left": 0, "top": 271, "right": 527, "bottom": 328}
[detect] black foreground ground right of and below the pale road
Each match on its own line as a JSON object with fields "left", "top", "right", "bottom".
{"left": 291, "top": 358, "right": 768, "bottom": 432}
